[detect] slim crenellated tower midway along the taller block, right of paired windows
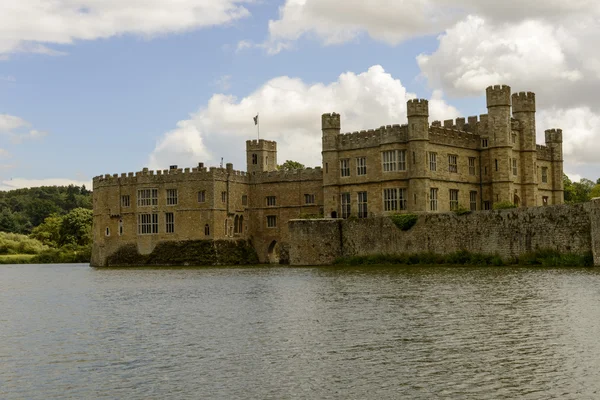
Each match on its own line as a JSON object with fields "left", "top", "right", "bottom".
{"left": 406, "top": 99, "right": 430, "bottom": 211}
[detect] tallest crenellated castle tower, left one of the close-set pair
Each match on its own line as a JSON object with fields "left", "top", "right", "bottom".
{"left": 486, "top": 85, "right": 514, "bottom": 203}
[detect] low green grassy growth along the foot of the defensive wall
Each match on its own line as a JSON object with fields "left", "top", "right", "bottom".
{"left": 334, "top": 249, "right": 594, "bottom": 267}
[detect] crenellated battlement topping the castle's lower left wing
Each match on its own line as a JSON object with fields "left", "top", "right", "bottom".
{"left": 92, "top": 167, "right": 248, "bottom": 190}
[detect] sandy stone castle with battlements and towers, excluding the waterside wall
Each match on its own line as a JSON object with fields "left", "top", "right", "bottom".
{"left": 92, "top": 86, "right": 564, "bottom": 266}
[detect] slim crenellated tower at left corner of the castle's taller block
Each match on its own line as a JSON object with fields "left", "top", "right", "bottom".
{"left": 321, "top": 113, "right": 341, "bottom": 217}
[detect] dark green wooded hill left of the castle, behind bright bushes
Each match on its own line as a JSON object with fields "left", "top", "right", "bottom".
{"left": 0, "top": 185, "right": 92, "bottom": 234}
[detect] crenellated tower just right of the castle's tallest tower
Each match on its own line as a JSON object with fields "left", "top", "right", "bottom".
{"left": 512, "top": 92, "right": 538, "bottom": 207}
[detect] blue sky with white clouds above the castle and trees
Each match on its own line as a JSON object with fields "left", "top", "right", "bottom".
{"left": 0, "top": 0, "right": 600, "bottom": 190}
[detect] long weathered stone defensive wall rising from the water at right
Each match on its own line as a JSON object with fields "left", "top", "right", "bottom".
{"left": 289, "top": 198, "right": 600, "bottom": 266}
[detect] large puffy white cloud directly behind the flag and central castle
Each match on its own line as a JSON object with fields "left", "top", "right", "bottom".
{"left": 149, "top": 65, "right": 460, "bottom": 169}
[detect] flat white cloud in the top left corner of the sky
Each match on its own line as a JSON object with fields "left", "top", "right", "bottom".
{"left": 0, "top": 0, "right": 252, "bottom": 55}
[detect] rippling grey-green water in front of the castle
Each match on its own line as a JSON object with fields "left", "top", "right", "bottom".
{"left": 0, "top": 265, "right": 600, "bottom": 399}
